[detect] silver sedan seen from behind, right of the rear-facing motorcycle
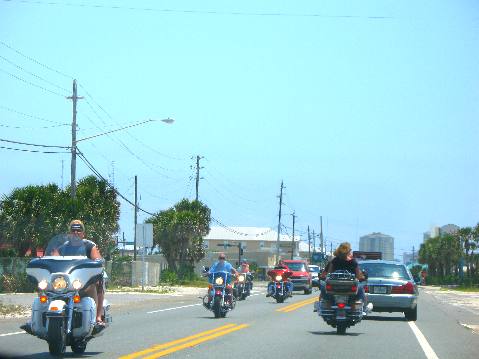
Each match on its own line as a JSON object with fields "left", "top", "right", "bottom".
{"left": 359, "top": 260, "right": 419, "bottom": 321}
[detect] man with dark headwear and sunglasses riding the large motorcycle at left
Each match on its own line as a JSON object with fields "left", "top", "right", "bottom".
{"left": 52, "top": 219, "right": 105, "bottom": 329}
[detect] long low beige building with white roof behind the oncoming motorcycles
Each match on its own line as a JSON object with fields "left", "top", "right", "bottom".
{"left": 200, "top": 226, "right": 300, "bottom": 278}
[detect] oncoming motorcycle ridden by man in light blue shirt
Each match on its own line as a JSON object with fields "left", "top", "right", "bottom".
{"left": 203, "top": 271, "right": 236, "bottom": 318}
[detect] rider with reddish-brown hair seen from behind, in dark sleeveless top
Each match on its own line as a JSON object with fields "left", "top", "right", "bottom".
{"left": 320, "top": 242, "right": 372, "bottom": 310}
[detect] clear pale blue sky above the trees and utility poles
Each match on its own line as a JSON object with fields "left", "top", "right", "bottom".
{"left": 0, "top": 0, "right": 479, "bottom": 257}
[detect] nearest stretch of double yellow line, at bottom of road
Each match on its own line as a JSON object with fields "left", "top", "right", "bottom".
{"left": 120, "top": 324, "right": 249, "bottom": 359}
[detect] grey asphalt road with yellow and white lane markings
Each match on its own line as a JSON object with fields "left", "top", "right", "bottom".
{"left": 0, "top": 288, "right": 479, "bottom": 359}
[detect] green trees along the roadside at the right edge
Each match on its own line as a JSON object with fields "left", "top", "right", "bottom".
{"left": 418, "top": 224, "right": 479, "bottom": 284}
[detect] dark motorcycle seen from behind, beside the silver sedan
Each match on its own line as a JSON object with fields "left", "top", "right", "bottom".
{"left": 315, "top": 270, "right": 364, "bottom": 334}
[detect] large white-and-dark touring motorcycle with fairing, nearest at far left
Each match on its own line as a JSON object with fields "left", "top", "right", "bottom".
{"left": 21, "top": 235, "right": 112, "bottom": 356}
